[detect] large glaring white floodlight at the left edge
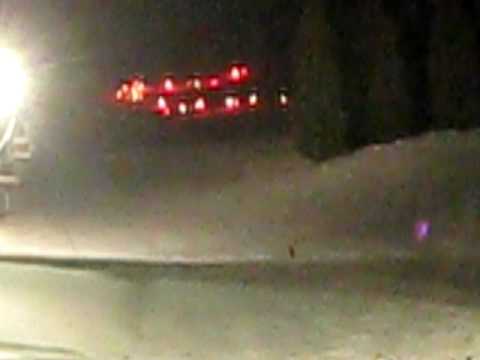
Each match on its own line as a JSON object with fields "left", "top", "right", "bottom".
{"left": 0, "top": 48, "right": 27, "bottom": 118}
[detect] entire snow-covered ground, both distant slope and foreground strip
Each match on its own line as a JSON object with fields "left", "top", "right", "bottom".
{"left": 0, "top": 111, "right": 480, "bottom": 360}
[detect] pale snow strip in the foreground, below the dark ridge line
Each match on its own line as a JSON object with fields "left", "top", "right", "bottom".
{"left": 0, "top": 262, "right": 480, "bottom": 360}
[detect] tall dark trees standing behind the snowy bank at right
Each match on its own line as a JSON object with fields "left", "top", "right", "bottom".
{"left": 291, "top": 0, "right": 480, "bottom": 158}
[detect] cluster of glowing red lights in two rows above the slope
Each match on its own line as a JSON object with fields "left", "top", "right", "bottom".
{"left": 115, "top": 63, "right": 289, "bottom": 117}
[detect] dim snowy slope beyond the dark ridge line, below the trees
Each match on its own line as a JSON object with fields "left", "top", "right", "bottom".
{"left": 0, "top": 114, "right": 480, "bottom": 263}
